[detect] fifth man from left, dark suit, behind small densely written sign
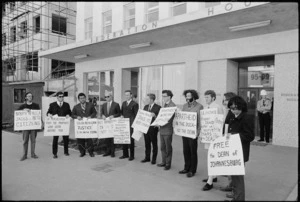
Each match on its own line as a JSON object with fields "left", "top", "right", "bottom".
{"left": 120, "top": 90, "right": 139, "bottom": 161}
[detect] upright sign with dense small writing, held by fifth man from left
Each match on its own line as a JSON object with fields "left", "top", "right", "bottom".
{"left": 114, "top": 118, "right": 130, "bottom": 144}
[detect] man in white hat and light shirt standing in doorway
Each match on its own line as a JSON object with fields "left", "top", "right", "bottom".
{"left": 257, "top": 90, "right": 272, "bottom": 143}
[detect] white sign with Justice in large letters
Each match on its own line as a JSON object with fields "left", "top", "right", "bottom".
{"left": 74, "top": 118, "right": 98, "bottom": 139}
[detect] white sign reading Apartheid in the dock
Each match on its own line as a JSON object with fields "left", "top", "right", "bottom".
{"left": 174, "top": 111, "right": 197, "bottom": 139}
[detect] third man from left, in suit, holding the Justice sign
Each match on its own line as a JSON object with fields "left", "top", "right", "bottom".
{"left": 72, "top": 93, "right": 97, "bottom": 157}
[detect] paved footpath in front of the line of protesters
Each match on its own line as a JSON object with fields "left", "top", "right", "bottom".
{"left": 2, "top": 131, "right": 298, "bottom": 201}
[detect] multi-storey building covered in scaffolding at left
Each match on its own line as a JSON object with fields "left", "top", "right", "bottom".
{"left": 2, "top": 1, "right": 76, "bottom": 123}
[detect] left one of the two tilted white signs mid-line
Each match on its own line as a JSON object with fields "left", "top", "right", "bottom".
{"left": 132, "top": 109, "right": 152, "bottom": 133}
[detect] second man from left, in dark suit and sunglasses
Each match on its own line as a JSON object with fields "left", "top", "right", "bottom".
{"left": 47, "top": 92, "right": 71, "bottom": 158}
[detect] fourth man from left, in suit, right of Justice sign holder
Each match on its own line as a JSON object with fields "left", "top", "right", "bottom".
{"left": 101, "top": 92, "right": 121, "bottom": 157}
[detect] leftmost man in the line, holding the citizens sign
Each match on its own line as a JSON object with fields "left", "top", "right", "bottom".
{"left": 18, "top": 92, "right": 40, "bottom": 161}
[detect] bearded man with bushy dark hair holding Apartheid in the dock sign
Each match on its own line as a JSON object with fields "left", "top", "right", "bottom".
{"left": 179, "top": 90, "right": 203, "bottom": 177}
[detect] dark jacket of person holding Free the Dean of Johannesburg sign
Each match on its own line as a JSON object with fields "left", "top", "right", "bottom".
{"left": 225, "top": 112, "right": 254, "bottom": 162}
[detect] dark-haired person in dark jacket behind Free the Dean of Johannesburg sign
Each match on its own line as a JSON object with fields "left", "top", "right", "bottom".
{"left": 225, "top": 96, "right": 254, "bottom": 201}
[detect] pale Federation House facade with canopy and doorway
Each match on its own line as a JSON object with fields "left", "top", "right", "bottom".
{"left": 40, "top": 2, "right": 299, "bottom": 147}
